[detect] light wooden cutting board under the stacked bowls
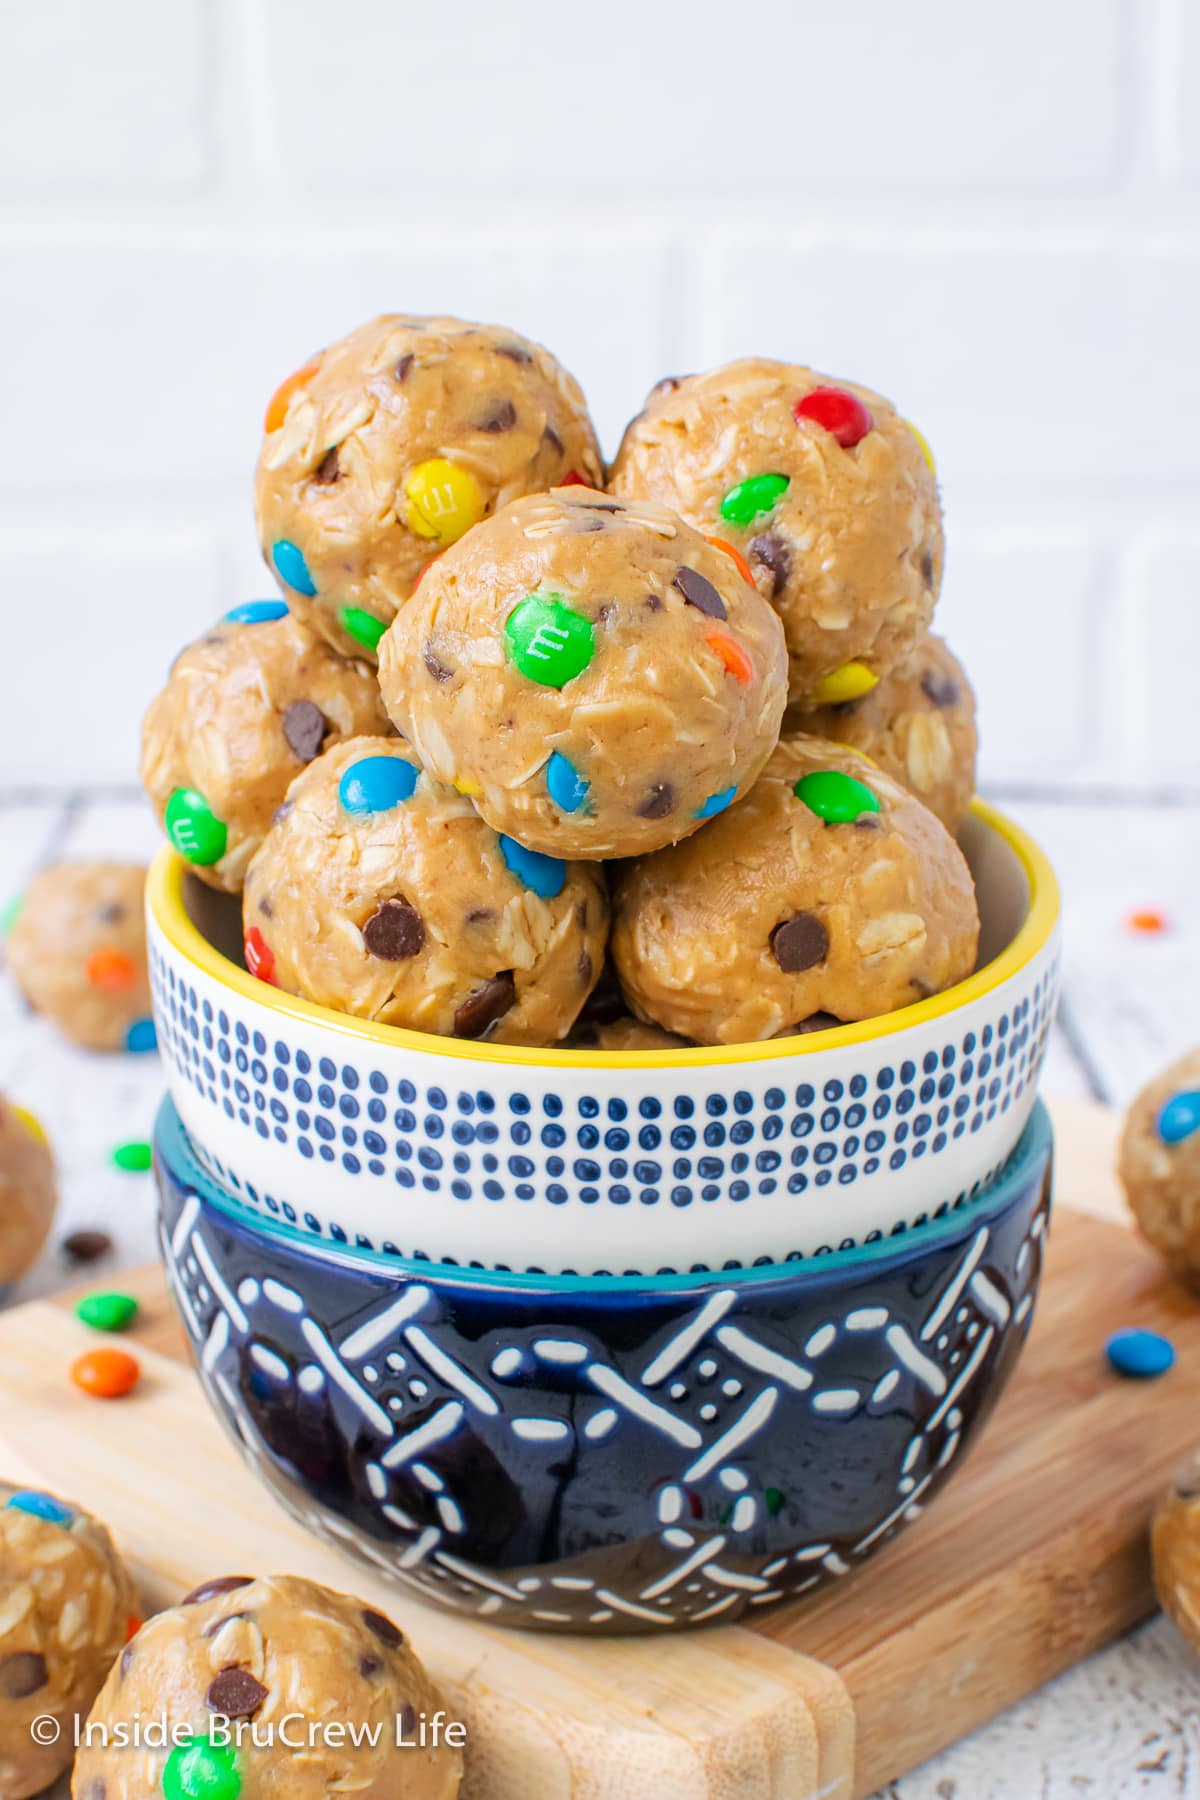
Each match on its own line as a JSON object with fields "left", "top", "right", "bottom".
{"left": 0, "top": 1105, "right": 1200, "bottom": 1800}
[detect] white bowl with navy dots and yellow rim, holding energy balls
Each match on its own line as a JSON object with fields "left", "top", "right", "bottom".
{"left": 148, "top": 802, "right": 1060, "bottom": 1274}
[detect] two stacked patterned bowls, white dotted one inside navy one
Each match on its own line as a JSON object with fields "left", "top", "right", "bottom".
{"left": 149, "top": 803, "right": 1058, "bottom": 1633}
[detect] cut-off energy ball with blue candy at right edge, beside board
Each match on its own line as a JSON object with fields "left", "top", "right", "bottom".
{"left": 1119, "top": 1049, "right": 1200, "bottom": 1292}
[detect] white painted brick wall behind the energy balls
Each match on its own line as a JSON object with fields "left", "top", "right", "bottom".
{"left": 0, "top": 0, "right": 1200, "bottom": 790}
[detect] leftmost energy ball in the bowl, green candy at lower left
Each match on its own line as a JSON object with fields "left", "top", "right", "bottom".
{"left": 142, "top": 599, "right": 390, "bottom": 893}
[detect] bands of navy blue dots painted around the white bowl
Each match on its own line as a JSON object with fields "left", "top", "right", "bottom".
{"left": 151, "top": 945, "right": 1056, "bottom": 1273}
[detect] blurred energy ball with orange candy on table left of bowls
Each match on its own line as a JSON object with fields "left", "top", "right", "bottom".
{"left": 5, "top": 862, "right": 155, "bottom": 1051}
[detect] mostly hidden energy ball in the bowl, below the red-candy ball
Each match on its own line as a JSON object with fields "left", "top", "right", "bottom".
{"left": 783, "top": 635, "right": 979, "bottom": 832}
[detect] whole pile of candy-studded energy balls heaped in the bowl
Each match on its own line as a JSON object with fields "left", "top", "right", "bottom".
{"left": 144, "top": 315, "right": 979, "bottom": 1049}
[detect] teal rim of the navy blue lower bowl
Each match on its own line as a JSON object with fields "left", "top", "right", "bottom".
{"left": 155, "top": 1098, "right": 1054, "bottom": 1294}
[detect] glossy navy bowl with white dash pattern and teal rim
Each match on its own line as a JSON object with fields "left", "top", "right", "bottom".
{"left": 157, "top": 1102, "right": 1051, "bottom": 1633}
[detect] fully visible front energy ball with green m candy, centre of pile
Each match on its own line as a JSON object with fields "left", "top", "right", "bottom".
{"left": 380, "top": 488, "right": 786, "bottom": 859}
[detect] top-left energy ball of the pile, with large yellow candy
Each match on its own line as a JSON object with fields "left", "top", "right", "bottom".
{"left": 255, "top": 313, "right": 601, "bottom": 655}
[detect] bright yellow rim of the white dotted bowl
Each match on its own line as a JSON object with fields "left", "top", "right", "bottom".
{"left": 146, "top": 799, "right": 1060, "bottom": 1071}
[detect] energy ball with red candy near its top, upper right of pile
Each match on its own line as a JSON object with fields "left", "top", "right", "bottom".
{"left": 610, "top": 356, "right": 943, "bottom": 707}
